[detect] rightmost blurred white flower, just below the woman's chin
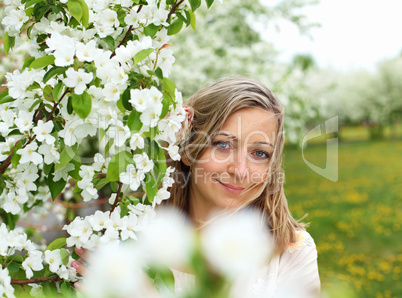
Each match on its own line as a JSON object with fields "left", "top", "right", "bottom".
{"left": 201, "top": 210, "right": 274, "bottom": 278}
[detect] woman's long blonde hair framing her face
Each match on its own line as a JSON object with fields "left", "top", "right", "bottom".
{"left": 166, "top": 77, "right": 304, "bottom": 252}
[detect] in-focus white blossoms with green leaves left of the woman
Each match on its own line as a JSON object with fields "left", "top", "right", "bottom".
{"left": 0, "top": 0, "right": 215, "bottom": 295}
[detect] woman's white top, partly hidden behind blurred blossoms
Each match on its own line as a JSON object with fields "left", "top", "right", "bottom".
{"left": 171, "top": 231, "right": 320, "bottom": 298}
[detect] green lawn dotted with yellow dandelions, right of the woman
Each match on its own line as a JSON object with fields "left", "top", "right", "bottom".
{"left": 285, "top": 136, "right": 402, "bottom": 297}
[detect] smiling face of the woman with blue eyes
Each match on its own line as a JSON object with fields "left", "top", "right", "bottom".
{"left": 190, "top": 108, "right": 277, "bottom": 217}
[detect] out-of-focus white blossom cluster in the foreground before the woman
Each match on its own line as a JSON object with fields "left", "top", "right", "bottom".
{"left": 83, "top": 208, "right": 274, "bottom": 297}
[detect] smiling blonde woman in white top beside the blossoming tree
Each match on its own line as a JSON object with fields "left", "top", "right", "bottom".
{"left": 166, "top": 77, "right": 320, "bottom": 297}
